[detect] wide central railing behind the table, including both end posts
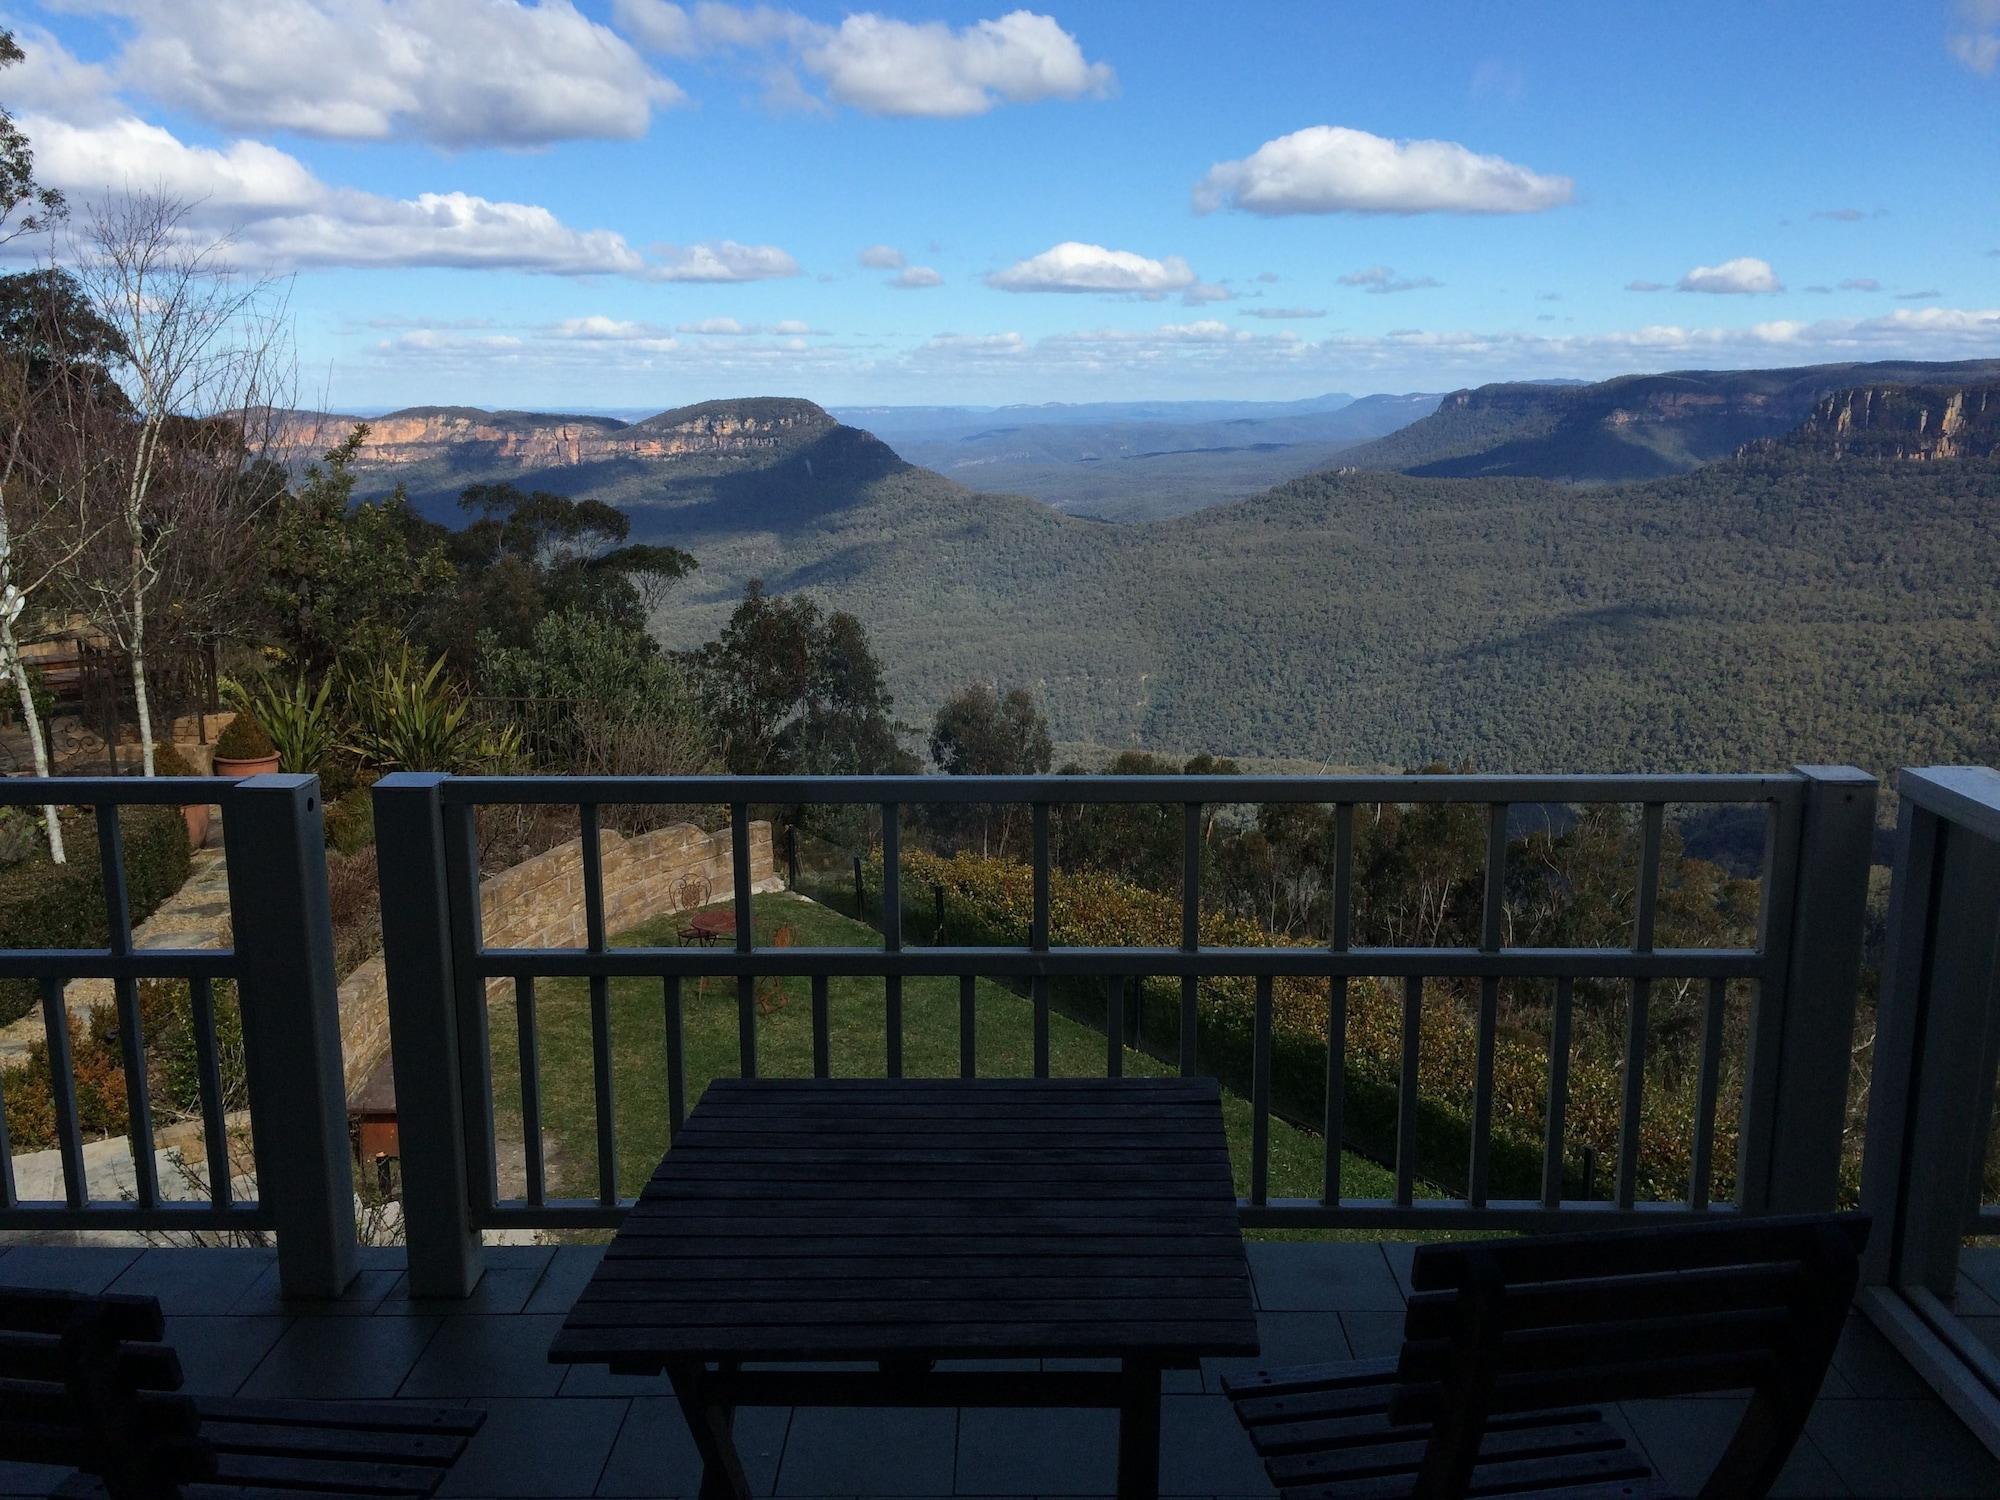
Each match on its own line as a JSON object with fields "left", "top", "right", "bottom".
{"left": 374, "top": 768, "right": 1876, "bottom": 1294}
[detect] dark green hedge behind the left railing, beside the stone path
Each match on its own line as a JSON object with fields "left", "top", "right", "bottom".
{"left": 0, "top": 806, "right": 192, "bottom": 1024}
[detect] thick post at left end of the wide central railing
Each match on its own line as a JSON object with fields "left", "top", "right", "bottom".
{"left": 374, "top": 772, "right": 484, "bottom": 1298}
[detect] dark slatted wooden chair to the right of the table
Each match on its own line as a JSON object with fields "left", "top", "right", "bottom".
{"left": 1224, "top": 1214, "right": 1868, "bottom": 1500}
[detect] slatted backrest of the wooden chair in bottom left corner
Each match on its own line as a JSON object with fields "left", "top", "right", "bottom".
{"left": 0, "top": 1286, "right": 214, "bottom": 1500}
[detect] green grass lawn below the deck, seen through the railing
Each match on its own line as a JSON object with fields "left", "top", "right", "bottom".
{"left": 490, "top": 892, "right": 1394, "bottom": 1224}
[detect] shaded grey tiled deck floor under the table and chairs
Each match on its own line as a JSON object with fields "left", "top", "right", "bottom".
{"left": 0, "top": 1244, "right": 2000, "bottom": 1498}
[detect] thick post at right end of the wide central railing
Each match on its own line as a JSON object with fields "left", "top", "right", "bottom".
{"left": 1738, "top": 766, "right": 1876, "bottom": 1214}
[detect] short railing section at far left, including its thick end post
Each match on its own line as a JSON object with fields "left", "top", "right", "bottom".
{"left": 0, "top": 776, "right": 356, "bottom": 1296}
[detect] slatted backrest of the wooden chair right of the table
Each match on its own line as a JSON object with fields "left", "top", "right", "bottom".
{"left": 1390, "top": 1214, "right": 1868, "bottom": 1496}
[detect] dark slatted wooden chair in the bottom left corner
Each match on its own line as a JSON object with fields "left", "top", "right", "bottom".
{"left": 0, "top": 1286, "right": 486, "bottom": 1500}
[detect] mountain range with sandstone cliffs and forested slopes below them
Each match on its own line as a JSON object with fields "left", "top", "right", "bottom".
{"left": 308, "top": 362, "right": 2000, "bottom": 770}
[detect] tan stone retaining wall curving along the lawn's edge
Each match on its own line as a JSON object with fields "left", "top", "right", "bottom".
{"left": 340, "top": 822, "right": 784, "bottom": 1098}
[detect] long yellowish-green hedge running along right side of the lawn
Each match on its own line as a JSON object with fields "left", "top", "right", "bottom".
{"left": 900, "top": 850, "right": 1736, "bottom": 1198}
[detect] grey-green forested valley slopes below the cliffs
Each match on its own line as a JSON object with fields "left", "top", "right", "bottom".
{"left": 634, "top": 454, "right": 2000, "bottom": 770}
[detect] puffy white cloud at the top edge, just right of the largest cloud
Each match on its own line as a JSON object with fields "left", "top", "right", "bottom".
{"left": 612, "top": 0, "right": 1118, "bottom": 118}
